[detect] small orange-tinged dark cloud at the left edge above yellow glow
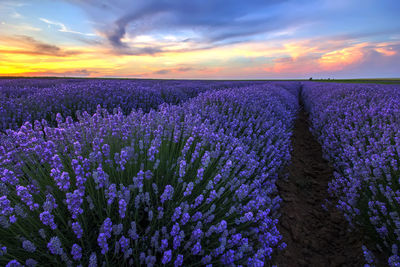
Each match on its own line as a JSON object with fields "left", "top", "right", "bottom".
{"left": 0, "top": 35, "right": 80, "bottom": 57}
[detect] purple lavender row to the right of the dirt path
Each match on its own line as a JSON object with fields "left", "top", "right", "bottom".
{"left": 302, "top": 83, "right": 400, "bottom": 266}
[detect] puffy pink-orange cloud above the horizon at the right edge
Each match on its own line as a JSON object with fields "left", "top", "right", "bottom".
{"left": 263, "top": 39, "right": 400, "bottom": 78}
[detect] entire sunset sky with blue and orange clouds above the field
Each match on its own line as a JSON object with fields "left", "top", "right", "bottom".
{"left": 0, "top": 0, "right": 400, "bottom": 79}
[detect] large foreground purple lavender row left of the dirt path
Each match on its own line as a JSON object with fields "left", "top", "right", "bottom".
{"left": 0, "top": 79, "right": 299, "bottom": 266}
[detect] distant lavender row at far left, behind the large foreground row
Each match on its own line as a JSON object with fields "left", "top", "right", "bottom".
{"left": 0, "top": 79, "right": 258, "bottom": 132}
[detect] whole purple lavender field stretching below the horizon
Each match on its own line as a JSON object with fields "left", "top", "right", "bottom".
{"left": 0, "top": 79, "right": 400, "bottom": 267}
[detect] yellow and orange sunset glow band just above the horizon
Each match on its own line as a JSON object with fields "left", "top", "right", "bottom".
{"left": 0, "top": 38, "right": 397, "bottom": 78}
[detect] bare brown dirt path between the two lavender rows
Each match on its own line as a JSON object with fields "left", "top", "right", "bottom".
{"left": 276, "top": 101, "right": 365, "bottom": 267}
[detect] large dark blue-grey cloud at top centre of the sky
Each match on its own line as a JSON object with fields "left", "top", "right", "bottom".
{"left": 69, "top": 0, "right": 310, "bottom": 54}
